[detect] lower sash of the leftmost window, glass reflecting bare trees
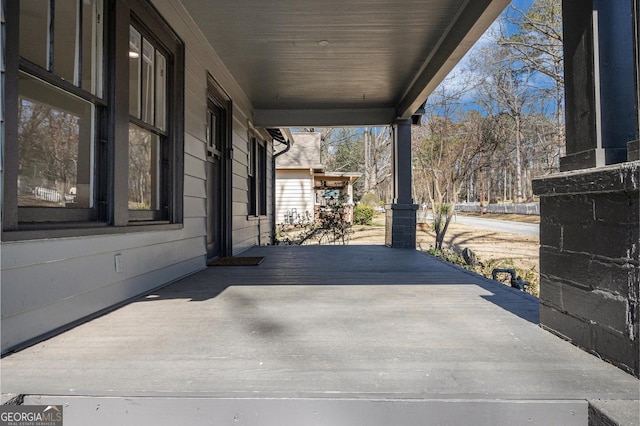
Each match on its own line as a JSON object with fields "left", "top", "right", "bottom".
{"left": 18, "top": 72, "right": 96, "bottom": 208}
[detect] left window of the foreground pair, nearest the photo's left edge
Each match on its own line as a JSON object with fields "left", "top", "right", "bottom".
{"left": 12, "top": 0, "right": 106, "bottom": 222}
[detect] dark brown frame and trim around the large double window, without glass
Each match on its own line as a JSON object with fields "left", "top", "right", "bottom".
{"left": 2, "top": 0, "right": 185, "bottom": 241}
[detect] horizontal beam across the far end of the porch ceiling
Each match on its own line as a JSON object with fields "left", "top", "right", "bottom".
{"left": 253, "top": 108, "right": 396, "bottom": 127}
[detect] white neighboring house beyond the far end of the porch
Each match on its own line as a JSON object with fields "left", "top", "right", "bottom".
{"left": 275, "top": 132, "right": 361, "bottom": 224}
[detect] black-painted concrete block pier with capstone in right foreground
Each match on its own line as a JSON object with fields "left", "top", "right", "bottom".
{"left": 533, "top": 161, "right": 640, "bottom": 376}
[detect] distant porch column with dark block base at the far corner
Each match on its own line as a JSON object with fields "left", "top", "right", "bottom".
{"left": 385, "top": 119, "right": 418, "bottom": 249}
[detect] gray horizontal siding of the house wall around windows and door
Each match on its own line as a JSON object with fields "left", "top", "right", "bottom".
{"left": 0, "top": 0, "right": 271, "bottom": 352}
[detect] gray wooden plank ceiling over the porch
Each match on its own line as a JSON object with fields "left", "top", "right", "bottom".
{"left": 182, "top": 0, "right": 509, "bottom": 127}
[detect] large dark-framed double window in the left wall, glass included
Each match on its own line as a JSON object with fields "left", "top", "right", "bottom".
{"left": 3, "top": 0, "right": 184, "bottom": 234}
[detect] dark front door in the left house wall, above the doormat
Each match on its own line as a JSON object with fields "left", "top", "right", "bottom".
{"left": 207, "top": 99, "right": 227, "bottom": 260}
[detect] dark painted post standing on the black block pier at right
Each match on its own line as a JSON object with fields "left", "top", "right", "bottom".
{"left": 560, "top": 0, "right": 638, "bottom": 171}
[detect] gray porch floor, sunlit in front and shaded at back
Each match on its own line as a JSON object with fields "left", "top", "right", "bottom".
{"left": 0, "top": 246, "right": 640, "bottom": 425}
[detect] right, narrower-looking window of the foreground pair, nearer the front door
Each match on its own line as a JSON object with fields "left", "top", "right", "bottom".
{"left": 120, "top": 0, "right": 184, "bottom": 224}
